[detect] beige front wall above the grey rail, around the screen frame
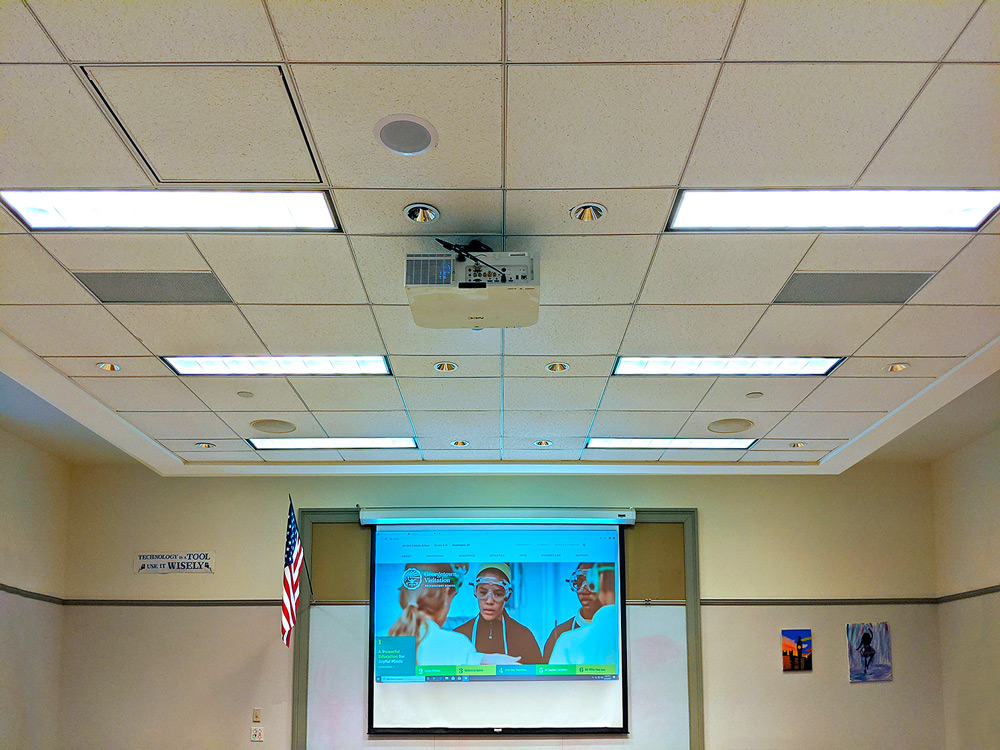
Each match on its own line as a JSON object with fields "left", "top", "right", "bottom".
{"left": 68, "top": 465, "right": 935, "bottom": 599}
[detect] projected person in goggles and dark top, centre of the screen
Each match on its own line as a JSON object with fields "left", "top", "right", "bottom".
{"left": 455, "top": 562, "right": 542, "bottom": 664}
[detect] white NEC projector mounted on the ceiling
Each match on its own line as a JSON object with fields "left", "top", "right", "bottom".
{"left": 406, "top": 252, "right": 539, "bottom": 328}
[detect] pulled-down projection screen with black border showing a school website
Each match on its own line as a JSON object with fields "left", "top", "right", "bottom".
{"left": 369, "top": 524, "right": 626, "bottom": 732}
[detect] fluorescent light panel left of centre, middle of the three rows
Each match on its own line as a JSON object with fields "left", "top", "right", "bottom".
{"left": 163, "top": 356, "right": 389, "bottom": 375}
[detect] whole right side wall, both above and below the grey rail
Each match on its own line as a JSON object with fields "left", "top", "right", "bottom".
{"left": 932, "top": 430, "right": 1000, "bottom": 750}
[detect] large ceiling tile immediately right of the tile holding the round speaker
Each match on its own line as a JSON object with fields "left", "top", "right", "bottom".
{"left": 506, "top": 63, "right": 720, "bottom": 188}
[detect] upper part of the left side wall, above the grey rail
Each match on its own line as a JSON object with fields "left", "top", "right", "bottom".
{"left": 0, "top": 431, "right": 69, "bottom": 596}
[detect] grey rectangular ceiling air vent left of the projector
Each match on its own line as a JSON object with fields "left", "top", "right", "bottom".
{"left": 76, "top": 271, "right": 233, "bottom": 305}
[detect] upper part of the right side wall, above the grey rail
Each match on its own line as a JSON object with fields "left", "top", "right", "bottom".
{"left": 931, "top": 430, "right": 1000, "bottom": 595}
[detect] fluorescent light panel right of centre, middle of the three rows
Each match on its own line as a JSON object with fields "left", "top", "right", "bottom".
{"left": 614, "top": 357, "right": 844, "bottom": 375}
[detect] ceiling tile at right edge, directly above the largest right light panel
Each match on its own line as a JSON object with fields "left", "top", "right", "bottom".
{"left": 858, "top": 64, "right": 1000, "bottom": 188}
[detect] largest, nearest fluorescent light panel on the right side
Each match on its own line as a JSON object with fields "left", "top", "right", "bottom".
{"left": 668, "top": 190, "right": 1000, "bottom": 231}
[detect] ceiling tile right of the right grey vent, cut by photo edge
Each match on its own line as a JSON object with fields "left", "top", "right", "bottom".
{"left": 912, "top": 234, "right": 1000, "bottom": 305}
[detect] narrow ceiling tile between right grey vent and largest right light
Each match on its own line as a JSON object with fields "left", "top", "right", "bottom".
{"left": 798, "top": 232, "right": 972, "bottom": 271}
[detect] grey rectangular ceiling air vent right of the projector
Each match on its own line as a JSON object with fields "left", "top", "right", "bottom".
{"left": 774, "top": 273, "right": 933, "bottom": 305}
